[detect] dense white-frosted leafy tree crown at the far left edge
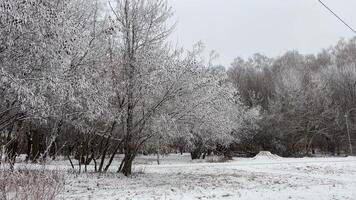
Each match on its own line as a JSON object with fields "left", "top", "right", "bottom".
{"left": 0, "top": 0, "right": 104, "bottom": 164}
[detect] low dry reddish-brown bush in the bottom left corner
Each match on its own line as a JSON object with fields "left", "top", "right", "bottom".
{"left": 0, "top": 170, "right": 64, "bottom": 200}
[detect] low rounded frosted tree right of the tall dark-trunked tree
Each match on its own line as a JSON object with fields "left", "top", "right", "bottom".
{"left": 149, "top": 44, "right": 258, "bottom": 159}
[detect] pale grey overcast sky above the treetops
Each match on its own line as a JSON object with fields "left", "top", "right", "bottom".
{"left": 169, "top": 0, "right": 356, "bottom": 66}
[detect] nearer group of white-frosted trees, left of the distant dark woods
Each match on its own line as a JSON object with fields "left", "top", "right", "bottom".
{"left": 0, "top": 0, "right": 259, "bottom": 175}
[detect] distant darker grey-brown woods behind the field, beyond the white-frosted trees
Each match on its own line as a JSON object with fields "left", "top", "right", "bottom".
{"left": 228, "top": 38, "right": 356, "bottom": 156}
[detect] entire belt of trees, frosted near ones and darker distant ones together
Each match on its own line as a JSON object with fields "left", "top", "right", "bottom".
{"left": 0, "top": 0, "right": 356, "bottom": 175}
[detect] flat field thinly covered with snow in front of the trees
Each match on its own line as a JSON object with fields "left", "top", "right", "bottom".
{"left": 15, "top": 154, "right": 356, "bottom": 200}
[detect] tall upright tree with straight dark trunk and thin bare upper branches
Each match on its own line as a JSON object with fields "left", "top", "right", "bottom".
{"left": 107, "top": 0, "right": 179, "bottom": 175}
